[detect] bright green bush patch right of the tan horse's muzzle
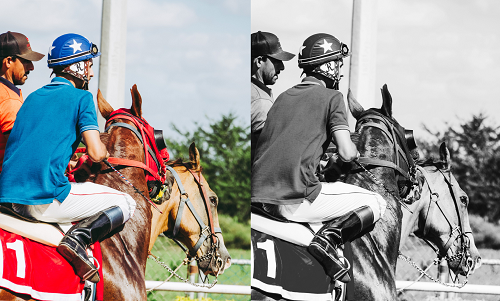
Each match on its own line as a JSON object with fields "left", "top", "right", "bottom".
{"left": 219, "top": 213, "right": 250, "bottom": 250}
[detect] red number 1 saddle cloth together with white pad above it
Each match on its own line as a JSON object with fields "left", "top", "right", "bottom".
{"left": 0, "top": 205, "right": 104, "bottom": 301}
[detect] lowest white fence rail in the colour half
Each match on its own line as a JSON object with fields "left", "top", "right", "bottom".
{"left": 146, "top": 281, "right": 250, "bottom": 295}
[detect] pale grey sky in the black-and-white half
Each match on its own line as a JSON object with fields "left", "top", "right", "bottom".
{"left": 251, "top": 0, "right": 500, "bottom": 140}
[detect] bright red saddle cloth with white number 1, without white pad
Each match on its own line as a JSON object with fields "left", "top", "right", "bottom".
{"left": 0, "top": 229, "right": 102, "bottom": 301}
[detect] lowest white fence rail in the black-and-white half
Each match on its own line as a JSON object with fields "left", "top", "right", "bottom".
{"left": 396, "top": 281, "right": 500, "bottom": 295}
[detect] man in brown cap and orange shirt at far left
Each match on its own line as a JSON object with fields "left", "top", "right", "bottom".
{"left": 0, "top": 31, "right": 45, "bottom": 172}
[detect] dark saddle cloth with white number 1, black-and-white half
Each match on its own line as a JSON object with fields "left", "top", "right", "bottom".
{"left": 252, "top": 229, "right": 335, "bottom": 301}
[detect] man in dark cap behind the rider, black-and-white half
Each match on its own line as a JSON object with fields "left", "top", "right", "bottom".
{"left": 251, "top": 31, "right": 295, "bottom": 163}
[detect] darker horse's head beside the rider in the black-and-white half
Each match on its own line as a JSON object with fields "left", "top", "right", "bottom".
{"left": 347, "top": 85, "right": 418, "bottom": 197}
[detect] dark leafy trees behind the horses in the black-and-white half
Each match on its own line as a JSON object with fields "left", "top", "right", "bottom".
{"left": 419, "top": 114, "right": 500, "bottom": 221}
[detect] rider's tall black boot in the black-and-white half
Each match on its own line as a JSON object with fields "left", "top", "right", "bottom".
{"left": 307, "top": 206, "right": 374, "bottom": 283}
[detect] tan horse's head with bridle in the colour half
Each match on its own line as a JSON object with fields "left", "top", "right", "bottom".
{"left": 149, "top": 143, "right": 231, "bottom": 275}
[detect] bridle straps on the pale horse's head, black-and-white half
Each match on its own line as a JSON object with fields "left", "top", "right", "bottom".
{"left": 417, "top": 165, "right": 472, "bottom": 276}
